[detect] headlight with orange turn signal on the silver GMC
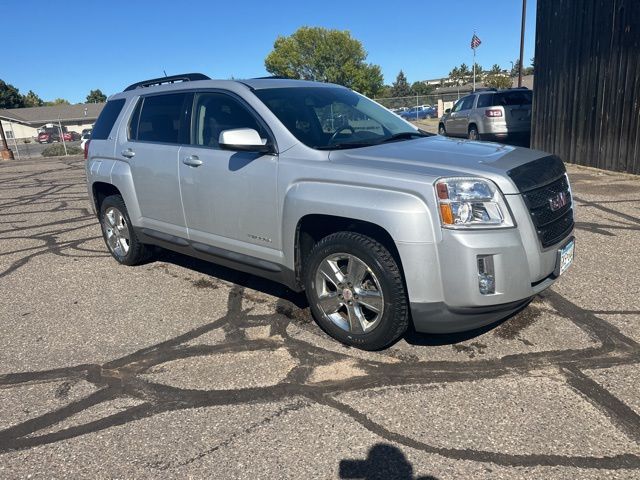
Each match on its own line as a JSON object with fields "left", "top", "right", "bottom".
{"left": 435, "top": 177, "right": 513, "bottom": 228}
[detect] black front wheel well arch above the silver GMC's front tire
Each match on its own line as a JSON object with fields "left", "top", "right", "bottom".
{"left": 295, "top": 214, "right": 404, "bottom": 284}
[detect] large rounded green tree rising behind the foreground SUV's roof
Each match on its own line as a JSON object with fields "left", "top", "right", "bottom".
{"left": 264, "top": 27, "right": 383, "bottom": 95}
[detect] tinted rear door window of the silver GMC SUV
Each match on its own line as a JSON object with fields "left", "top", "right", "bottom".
{"left": 136, "top": 93, "right": 188, "bottom": 143}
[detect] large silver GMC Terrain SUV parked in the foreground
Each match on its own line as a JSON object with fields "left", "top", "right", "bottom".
{"left": 86, "top": 74, "right": 574, "bottom": 349}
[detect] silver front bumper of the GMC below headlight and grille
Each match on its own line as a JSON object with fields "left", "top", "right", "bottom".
{"left": 399, "top": 203, "right": 572, "bottom": 333}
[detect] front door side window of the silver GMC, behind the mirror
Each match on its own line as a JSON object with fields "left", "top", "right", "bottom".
{"left": 192, "top": 93, "right": 267, "bottom": 148}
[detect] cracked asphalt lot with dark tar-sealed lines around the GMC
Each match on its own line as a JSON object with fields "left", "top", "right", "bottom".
{"left": 0, "top": 158, "right": 640, "bottom": 480}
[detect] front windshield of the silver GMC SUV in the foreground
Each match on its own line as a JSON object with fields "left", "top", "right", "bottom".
{"left": 255, "top": 87, "right": 426, "bottom": 150}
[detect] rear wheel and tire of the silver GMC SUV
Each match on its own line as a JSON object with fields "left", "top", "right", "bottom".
{"left": 100, "top": 195, "right": 151, "bottom": 265}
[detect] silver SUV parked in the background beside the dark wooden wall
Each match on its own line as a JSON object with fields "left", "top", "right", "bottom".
{"left": 438, "top": 87, "right": 533, "bottom": 145}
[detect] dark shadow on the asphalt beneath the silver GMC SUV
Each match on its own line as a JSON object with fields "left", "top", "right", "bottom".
{"left": 155, "top": 249, "right": 504, "bottom": 347}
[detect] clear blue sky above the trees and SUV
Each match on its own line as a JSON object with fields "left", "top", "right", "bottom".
{"left": 5, "top": 0, "right": 536, "bottom": 103}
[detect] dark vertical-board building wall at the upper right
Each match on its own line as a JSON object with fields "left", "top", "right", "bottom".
{"left": 531, "top": 0, "right": 640, "bottom": 174}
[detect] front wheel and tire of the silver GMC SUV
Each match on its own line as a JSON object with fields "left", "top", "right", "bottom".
{"left": 304, "top": 232, "right": 409, "bottom": 350}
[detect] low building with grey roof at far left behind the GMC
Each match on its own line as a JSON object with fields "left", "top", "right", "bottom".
{"left": 0, "top": 103, "right": 105, "bottom": 140}
